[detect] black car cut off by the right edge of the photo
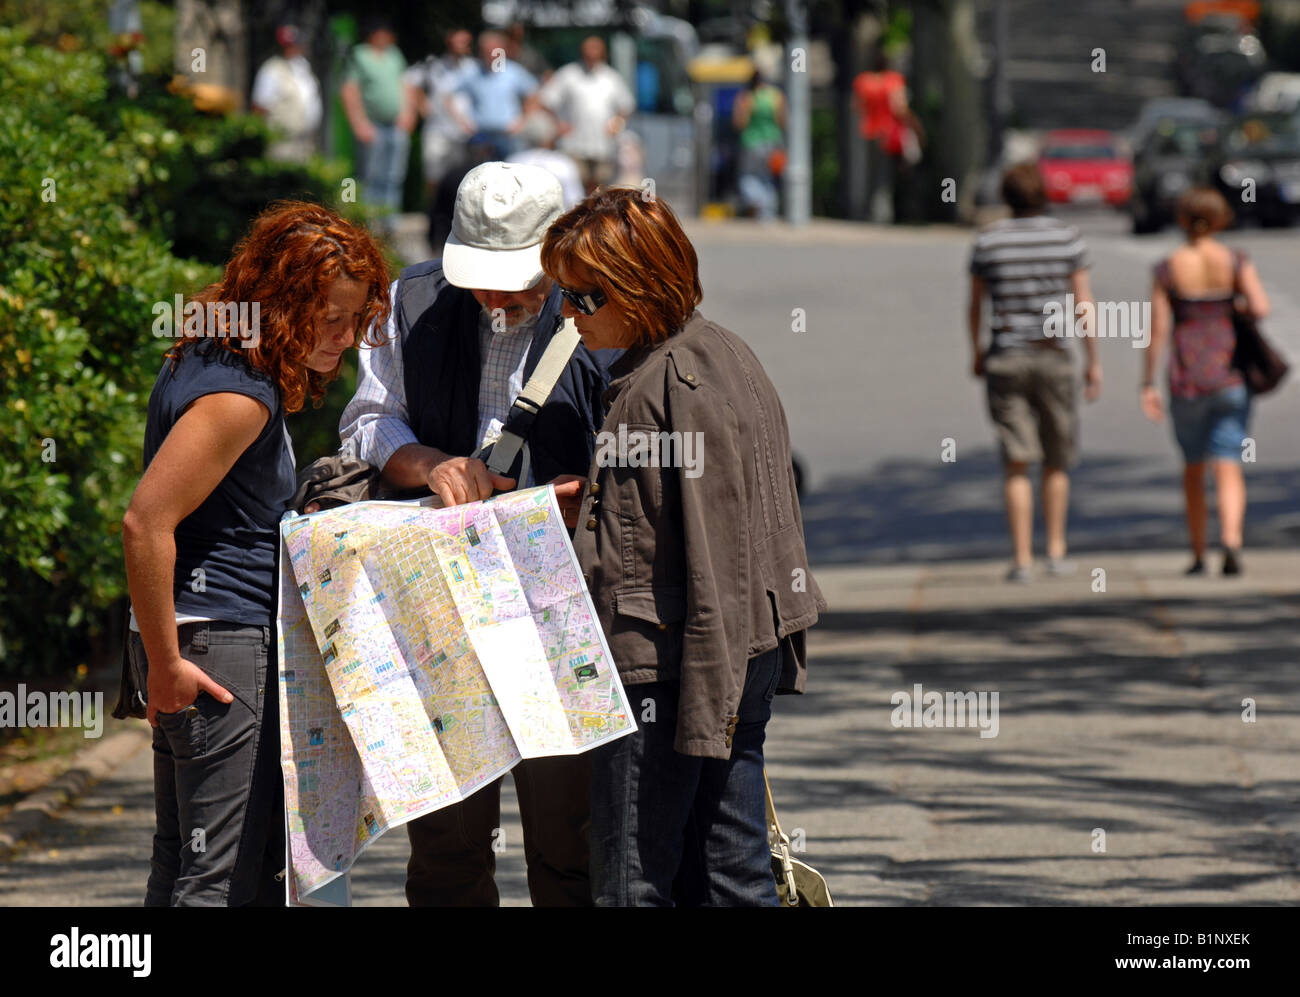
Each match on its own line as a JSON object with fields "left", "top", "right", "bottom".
{"left": 1209, "top": 112, "right": 1300, "bottom": 225}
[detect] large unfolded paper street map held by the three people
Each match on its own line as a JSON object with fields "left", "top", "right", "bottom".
{"left": 278, "top": 486, "right": 636, "bottom": 902}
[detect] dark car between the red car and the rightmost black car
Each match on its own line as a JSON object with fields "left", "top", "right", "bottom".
{"left": 1128, "top": 116, "right": 1219, "bottom": 233}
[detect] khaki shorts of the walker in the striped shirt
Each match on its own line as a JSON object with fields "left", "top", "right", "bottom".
{"left": 984, "top": 347, "right": 1079, "bottom": 468}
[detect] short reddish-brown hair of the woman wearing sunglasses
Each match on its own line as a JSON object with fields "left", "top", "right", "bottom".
{"left": 542, "top": 187, "right": 705, "bottom": 344}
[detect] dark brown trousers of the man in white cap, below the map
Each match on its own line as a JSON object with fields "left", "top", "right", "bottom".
{"left": 407, "top": 754, "right": 592, "bottom": 907}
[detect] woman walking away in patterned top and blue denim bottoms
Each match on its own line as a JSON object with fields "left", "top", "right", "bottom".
{"left": 1141, "top": 187, "right": 1269, "bottom": 575}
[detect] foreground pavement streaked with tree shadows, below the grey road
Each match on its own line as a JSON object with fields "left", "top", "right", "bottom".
{"left": 0, "top": 550, "right": 1300, "bottom": 906}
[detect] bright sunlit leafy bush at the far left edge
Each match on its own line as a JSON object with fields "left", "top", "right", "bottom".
{"left": 0, "top": 30, "right": 213, "bottom": 673}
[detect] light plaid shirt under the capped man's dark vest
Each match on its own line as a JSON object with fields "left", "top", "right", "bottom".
{"left": 338, "top": 281, "right": 537, "bottom": 487}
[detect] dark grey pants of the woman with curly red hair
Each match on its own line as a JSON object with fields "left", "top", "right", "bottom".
{"left": 130, "top": 621, "right": 285, "bottom": 907}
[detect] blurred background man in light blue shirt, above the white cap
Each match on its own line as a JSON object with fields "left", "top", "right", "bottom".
{"left": 443, "top": 31, "right": 538, "bottom": 160}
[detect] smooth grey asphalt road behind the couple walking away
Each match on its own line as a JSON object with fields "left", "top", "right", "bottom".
{"left": 690, "top": 212, "right": 1300, "bottom": 564}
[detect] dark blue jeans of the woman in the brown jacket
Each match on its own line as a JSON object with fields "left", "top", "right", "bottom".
{"left": 592, "top": 646, "right": 781, "bottom": 907}
